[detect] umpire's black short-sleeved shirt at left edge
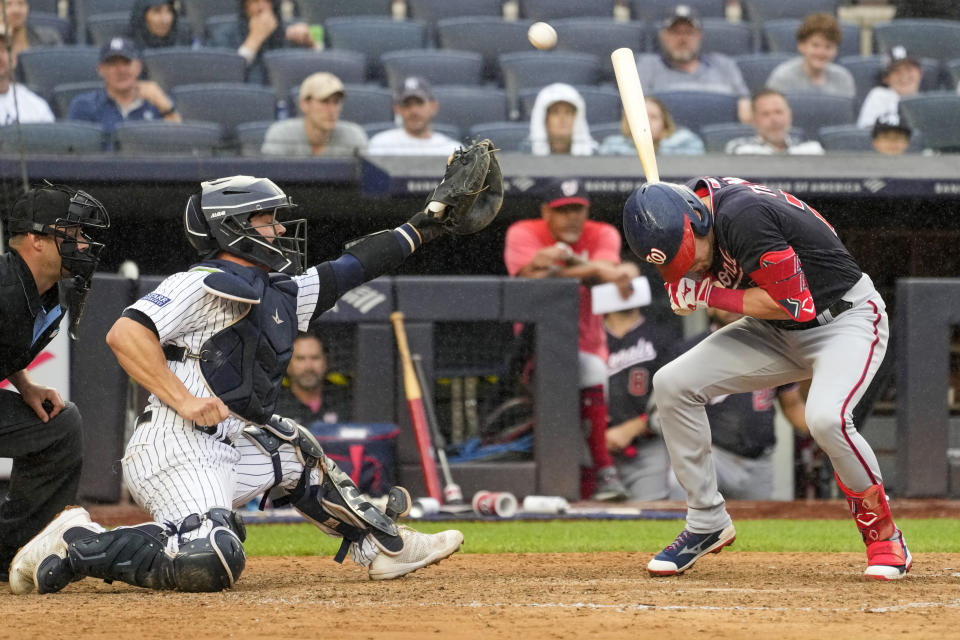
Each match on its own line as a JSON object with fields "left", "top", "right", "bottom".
{"left": 0, "top": 249, "right": 65, "bottom": 380}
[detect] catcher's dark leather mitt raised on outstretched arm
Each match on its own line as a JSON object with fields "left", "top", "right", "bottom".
{"left": 427, "top": 139, "right": 503, "bottom": 235}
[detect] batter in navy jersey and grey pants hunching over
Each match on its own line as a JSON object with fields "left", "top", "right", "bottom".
{"left": 623, "top": 177, "right": 912, "bottom": 580}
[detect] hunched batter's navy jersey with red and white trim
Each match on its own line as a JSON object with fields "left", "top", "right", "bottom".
{"left": 687, "top": 177, "right": 862, "bottom": 313}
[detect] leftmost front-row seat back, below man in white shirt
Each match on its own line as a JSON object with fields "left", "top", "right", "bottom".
{"left": 0, "top": 120, "right": 105, "bottom": 154}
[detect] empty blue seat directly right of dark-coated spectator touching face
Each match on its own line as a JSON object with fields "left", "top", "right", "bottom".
{"left": 323, "top": 16, "right": 426, "bottom": 81}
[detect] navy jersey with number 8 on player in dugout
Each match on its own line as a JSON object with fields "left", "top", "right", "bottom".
{"left": 607, "top": 317, "right": 667, "bottom": 425}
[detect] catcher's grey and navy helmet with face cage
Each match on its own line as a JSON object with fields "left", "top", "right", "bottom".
{"left": 183, "top": 176, "right": 307, "bottom": 275}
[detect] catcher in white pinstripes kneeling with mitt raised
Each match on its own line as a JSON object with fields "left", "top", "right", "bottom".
{"left": 10, "top": 140, "right": 503, "bottom": 594}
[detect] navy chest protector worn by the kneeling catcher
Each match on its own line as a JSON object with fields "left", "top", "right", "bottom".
{"left": 193, "top": 260, "right": 298, "bottom": 424}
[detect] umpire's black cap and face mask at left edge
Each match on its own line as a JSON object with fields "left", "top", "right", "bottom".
{"left": 6, "top": 183, "right": 110, "bottom": 286}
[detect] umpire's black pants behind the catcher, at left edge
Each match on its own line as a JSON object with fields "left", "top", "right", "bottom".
{"left": 0, "top": 389, "right": 83, "bottom": 577}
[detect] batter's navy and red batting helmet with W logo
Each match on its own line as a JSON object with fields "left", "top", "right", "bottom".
{"left": 623, "top": 182, "right": 713, "bottom": 282}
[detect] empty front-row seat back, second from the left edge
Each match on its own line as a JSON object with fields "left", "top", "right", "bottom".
{"left": 113, "top": 120, "right": 222, "bottom": 157}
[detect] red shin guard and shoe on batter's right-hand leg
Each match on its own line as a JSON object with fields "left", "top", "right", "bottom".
{"left": 836, "top": 476, "right": 913, "bottom": 580}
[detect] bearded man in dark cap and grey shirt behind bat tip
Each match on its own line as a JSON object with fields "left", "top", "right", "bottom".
{"left": 637, "top": 4, "right": 750, "bottom": 122}
